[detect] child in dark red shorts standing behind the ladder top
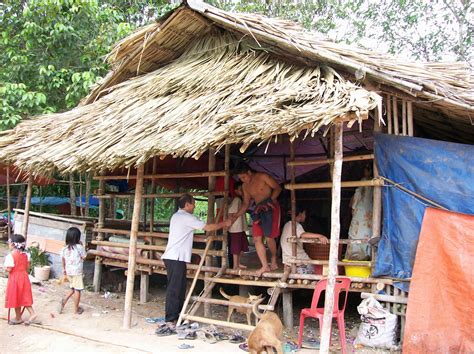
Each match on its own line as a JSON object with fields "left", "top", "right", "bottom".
{"left": 229, "top": 182, "right": 249, "bottom": 269}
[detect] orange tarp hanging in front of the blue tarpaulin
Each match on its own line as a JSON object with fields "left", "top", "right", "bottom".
{"left": 403, "top": 208, "right": 474, "bottom": 354}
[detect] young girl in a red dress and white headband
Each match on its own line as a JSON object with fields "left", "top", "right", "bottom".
{"left": 4, "top": 234, "right": 38, "bottom": 325}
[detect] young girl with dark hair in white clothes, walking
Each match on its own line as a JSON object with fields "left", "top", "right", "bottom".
{"left": 59, "top": 227, "right": 86, "bottom": 315}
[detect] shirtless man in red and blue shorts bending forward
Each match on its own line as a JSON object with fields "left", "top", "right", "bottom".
{"left": 231, "top": 166, "right": 281, "bottom": 276}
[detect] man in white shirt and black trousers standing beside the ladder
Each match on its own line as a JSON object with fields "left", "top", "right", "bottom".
{"left": 156, "top": 194, "right": 231, "bottom": 335}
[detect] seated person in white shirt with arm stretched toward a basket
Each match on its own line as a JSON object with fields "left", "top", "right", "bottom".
{"left": 280, "top": 207, "right": 328, "bottom": 274}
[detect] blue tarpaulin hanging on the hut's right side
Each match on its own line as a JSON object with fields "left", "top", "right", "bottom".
{"left": 373, "top": 134, "right": 474, "bottom": 290}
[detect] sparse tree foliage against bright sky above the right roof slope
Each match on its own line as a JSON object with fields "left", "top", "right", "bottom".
{"left": 208, "top": 0, "right": 474, "bottom": 61}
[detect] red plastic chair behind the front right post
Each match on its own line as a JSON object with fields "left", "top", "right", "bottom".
{"left": 298, "top": 277, "right": 351, "bottom": 353}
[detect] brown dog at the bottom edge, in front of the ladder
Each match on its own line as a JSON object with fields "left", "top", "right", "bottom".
{"left": 247, "top": 306, "right": 283, "bottom": 354}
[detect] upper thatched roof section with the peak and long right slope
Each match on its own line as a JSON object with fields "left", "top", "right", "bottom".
{"left": 85, "top": 1, "right": 474, "bottom": 124}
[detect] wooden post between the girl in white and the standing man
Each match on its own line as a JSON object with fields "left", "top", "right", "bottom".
{"left": 123, "top": 164, "right": 145, "bottom": 329}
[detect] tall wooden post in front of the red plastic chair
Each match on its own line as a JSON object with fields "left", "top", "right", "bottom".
{"left": 320, "top": 123, "right": 343, "bottom": 353}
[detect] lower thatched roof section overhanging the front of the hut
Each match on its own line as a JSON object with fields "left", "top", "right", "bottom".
{"left": 0, "top": 31, "right": 380, "bottom": 174}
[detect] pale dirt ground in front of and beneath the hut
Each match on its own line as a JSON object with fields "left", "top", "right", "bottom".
{"left": 0, "top": 243, "right": 398, "bottom": 354}
